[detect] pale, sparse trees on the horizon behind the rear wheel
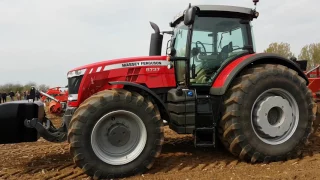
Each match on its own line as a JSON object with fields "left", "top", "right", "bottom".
{"left": 264, "top": 42, "right": 320, "bottom": 69}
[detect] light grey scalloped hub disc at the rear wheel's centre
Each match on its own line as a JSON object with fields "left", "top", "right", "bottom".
{"left": 254, "top": 96, "right": 293, "bottom": 138}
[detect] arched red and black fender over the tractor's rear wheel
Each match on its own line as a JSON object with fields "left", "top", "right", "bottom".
{"left": 210, "top": 53, "right": 309, "bottom": 95}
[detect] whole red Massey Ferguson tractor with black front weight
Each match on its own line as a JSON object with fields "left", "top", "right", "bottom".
{"left": 0, "top": 0, "right": 317, "bottom": 179}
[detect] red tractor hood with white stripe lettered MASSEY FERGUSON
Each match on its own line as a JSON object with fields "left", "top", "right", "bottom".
{"left": 68, "top": 56, "right": 175, "bottom": 107}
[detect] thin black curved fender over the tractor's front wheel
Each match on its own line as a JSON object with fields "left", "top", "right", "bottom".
{"left": 109, "top": 81, "right": 170, "bottom": 122}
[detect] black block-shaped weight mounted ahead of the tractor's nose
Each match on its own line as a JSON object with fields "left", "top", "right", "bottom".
{"left": 0, "top": 101, "right": 45, "bottom": 144}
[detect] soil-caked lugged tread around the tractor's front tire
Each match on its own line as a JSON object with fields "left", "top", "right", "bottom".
{"left": 68, "top": 89, "right": 164, "bottom": 179}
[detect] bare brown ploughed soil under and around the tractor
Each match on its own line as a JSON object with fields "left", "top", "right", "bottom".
{"left": 0, "top": 115, "right": 320, "bottom": 180}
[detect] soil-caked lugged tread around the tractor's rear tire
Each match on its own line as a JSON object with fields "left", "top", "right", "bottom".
{"left": 219, "top": 64, "right": 315, "bottom": 163}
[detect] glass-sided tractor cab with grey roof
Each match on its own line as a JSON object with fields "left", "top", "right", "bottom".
{"left": 150, "top": 5, "right": 259, "bottom": 92}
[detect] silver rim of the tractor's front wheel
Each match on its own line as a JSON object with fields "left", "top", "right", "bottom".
{"left": 91, "top": 110, "right": 147, "bottom": 165}
